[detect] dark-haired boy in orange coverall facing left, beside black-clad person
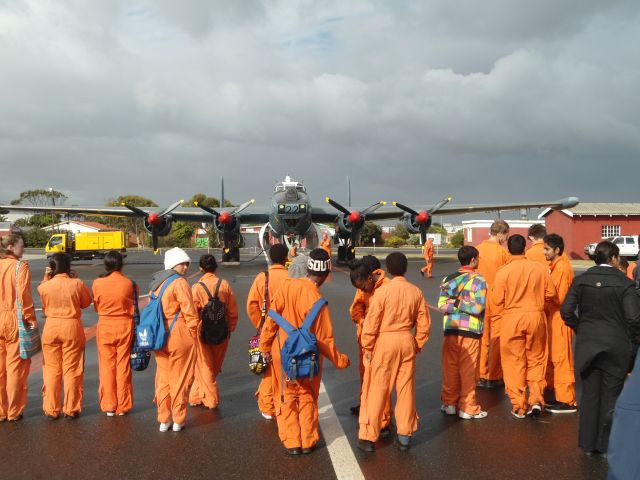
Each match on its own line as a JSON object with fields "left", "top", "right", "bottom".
{"left": 544, "top": 233, "right": 578, "bottom": 413}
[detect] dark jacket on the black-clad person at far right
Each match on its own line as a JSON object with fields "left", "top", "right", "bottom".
{"left": 560, "top": 265, "right": 640, "bottom": 379}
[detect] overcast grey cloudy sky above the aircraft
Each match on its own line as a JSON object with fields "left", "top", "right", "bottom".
{"left": 0, "top": 0, "right": 640, "bottom": 213}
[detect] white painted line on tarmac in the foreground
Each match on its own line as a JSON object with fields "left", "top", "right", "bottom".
{"left": 318, "top": 382, "right": 364, "bottom": 480}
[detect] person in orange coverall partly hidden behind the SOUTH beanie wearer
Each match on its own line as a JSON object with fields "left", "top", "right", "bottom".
{"left": 247, "top": 243, "right": 289, "bottom": 420}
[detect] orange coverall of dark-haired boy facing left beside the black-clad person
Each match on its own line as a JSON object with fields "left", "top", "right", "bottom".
{"left": 546, "top": 256, "right": 576, "bottom": 405}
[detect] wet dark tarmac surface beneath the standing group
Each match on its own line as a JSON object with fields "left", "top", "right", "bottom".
{"left": 0, "top": 251, "right": 607, "bottom": 480}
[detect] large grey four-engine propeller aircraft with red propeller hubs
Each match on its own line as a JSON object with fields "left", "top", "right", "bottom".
{"left": 0, "top": 176, "right": 578, "bottom": 262}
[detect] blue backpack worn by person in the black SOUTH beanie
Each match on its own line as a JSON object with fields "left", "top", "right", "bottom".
{"left": 269, "top": 298, "right": 327, "bottom": 381}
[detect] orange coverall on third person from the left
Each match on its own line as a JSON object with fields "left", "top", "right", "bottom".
{"left": 92, "top": 272, "right": 138, "bottom": 414}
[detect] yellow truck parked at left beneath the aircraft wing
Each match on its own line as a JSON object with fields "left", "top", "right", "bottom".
{"left": 45, "top": 232, "right": 127, "bottom": 260}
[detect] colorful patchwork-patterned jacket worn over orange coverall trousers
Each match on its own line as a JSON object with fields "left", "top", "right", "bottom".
{"left": 438, "top": 267, "right": 487, "bottom": 338}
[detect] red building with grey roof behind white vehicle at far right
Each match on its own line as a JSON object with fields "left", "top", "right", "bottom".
{"left": 538, "top": 203, "right": 640, "bottom": 259}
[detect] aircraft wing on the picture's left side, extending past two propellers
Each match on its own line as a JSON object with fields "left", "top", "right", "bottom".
{"left": 0, "top": 205, "right": 269, "bottom": 223}
